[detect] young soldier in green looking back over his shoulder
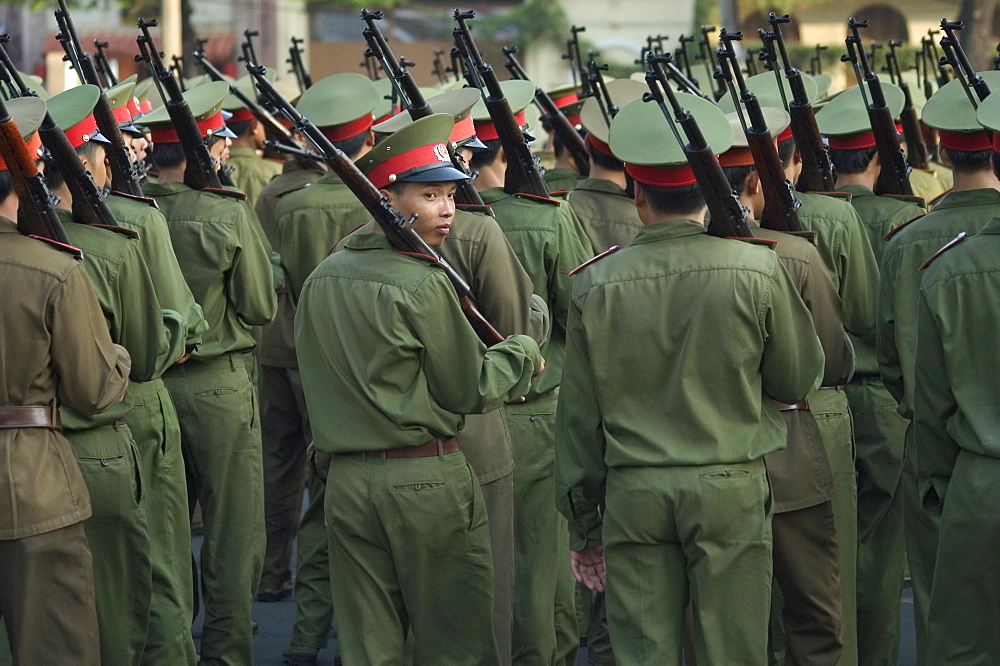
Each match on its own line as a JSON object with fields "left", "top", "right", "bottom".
{"left": 296, "top": 114, "right": 543, "bottom": 664}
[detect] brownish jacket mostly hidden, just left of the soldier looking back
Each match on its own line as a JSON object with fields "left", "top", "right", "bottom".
{"left": 254, "top": 160, "right": 324, "bottom": 368}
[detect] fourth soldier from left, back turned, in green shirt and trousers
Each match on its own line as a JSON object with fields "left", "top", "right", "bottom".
{"left": 143, "top": 82, "right": 276, "bottom": 663}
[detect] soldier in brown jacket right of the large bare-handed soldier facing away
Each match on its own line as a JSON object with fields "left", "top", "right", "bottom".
{"left": 719, "top": 107, "right": 854, "bottom": 664}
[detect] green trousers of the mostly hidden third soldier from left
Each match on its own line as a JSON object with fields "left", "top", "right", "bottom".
{"left": 128, "top": 379, "right": 197, "bottom": 664}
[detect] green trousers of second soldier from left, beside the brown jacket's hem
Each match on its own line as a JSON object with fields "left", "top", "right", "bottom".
{"left": 66, "top": 423, "right": 152, "bottom": 664}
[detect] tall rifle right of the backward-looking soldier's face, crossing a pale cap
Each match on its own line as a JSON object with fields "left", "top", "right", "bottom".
{"left": 453, "top": 9, "right": 549, "bottom": 198}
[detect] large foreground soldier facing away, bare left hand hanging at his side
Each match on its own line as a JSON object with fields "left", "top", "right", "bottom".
{"left": 555, "top": 97, "right": 823, "bottom": 664}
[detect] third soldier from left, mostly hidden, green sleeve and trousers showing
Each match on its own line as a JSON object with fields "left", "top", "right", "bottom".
{"left": 101, "top": 78, "right": 208, "bottom": 663}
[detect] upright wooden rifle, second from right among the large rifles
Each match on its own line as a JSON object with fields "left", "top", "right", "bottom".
{"left": 845, "top": 16, "right": 913, "bottom": 195}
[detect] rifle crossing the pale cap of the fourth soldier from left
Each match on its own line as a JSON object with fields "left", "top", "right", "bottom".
{"left": 135, "top": 18, "right": 222, "bottom": 190}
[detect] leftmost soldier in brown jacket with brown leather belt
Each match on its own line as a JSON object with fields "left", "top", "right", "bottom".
{"left": 0, "top": 93, "right": 130, "bottom": 664}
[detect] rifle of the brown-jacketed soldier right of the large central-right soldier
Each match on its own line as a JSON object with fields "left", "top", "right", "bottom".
{"left": 719, "top": 28, "right": 802, "bottom": 232}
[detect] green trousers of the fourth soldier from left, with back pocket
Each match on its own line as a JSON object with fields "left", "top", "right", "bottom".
{"left": 163, "top": 353, "right": 264, "bottom": 664}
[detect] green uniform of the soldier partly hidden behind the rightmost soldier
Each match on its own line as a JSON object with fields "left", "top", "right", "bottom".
{"left": 877, "top": 184, "right": 1000, "bottom": 658}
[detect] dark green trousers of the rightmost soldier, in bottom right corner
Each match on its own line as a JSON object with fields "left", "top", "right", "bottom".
{"left": 926, "top": 450, "right": 1000, "bottom": 664}
